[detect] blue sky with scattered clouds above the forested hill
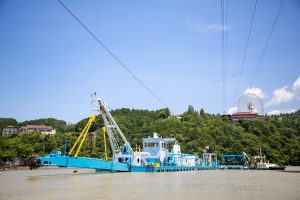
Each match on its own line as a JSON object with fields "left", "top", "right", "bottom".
{"left": 0, "top": 0, "right": 300, "bottom": 123}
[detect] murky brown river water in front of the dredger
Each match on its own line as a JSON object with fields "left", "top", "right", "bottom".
{"left": 0, "top": 167, "right": 300, "bottom": 200}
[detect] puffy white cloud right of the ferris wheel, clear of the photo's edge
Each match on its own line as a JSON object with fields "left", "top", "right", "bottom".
{"left": 266, "top": 86, "right": 295, "bottom": 107}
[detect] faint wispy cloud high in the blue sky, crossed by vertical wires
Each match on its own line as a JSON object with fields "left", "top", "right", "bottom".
{"left": 185, "top": 20, "right": 230, "bottom": 33}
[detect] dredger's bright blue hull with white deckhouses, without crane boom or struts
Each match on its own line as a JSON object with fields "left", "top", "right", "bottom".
{"left": 39, "top": 133, "right": 218, "bottom": 172}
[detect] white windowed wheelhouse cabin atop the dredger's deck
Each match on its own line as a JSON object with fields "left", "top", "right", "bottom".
{"left": 143, "top": 133, "right": 176, "bottom": 163}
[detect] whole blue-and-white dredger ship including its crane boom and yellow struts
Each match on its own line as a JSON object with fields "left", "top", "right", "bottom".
{"left": 37, "top": 99, "right": 218, "bottom": 172}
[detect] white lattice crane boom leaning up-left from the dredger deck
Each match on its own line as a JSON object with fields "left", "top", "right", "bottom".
{"left": 98, "top": 99, "right": 133, "bottom": 160}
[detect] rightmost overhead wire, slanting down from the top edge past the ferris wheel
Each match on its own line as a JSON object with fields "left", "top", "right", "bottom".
{"left": 250, "top": 0, "right": 285, "bottom": 86}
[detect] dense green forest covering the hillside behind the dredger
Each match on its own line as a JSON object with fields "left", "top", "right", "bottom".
{"left": 0, "top": 106, "right": 300, "bottom": 165}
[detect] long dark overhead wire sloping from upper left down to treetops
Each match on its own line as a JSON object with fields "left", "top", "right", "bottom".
{"left": 57, "top": 0, "right": 171, "bottom": 109}
